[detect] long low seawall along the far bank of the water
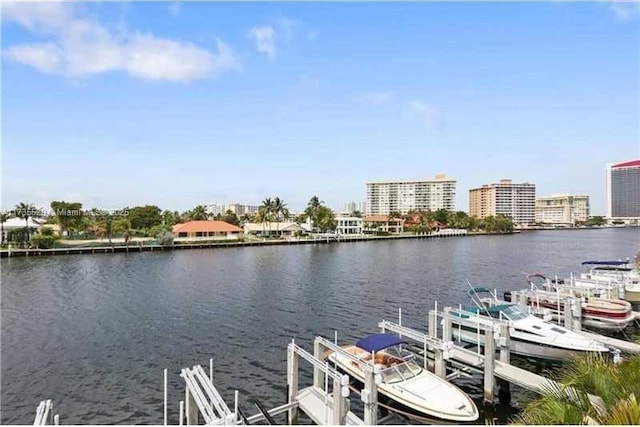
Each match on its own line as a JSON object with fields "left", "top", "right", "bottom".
{"left": 0, "top": 232, "right": 504, "bottom": 258}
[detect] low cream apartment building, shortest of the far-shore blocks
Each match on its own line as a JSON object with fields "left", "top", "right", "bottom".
{"left": 536, "top": 194, "right": 589, "bottom": 226}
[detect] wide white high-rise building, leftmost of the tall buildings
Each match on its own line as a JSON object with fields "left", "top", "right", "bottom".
{"left": 365, "top": 174, "right": 456, "bottom": 215}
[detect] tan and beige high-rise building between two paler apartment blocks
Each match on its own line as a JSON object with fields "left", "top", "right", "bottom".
{"left": 469, "top": 179, "right": 536, "bottom": 224}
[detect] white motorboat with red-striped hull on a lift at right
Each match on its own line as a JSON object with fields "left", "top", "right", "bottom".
{"left": 504, "top": 273, "right": 635, "bottom": 332}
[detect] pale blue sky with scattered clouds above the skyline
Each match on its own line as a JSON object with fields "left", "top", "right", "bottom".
{"left": 1, "top": 2, "right": 640, "bottom": 215}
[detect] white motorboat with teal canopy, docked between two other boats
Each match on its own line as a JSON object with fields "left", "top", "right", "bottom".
{"left": 449, "top": 288, "right": 611, "bottom": 361}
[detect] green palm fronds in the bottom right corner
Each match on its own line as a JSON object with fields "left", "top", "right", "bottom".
{"left": 514, "top": 355, "right": 640, "bottom": 425}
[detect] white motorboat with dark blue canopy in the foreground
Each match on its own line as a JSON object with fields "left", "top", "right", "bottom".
{"left": 327, "top": 334, "right": 479, "bottom": 422}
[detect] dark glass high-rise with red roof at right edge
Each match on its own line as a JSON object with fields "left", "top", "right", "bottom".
{"left": 607, "top": 160, "right": 640, "bottom": 222}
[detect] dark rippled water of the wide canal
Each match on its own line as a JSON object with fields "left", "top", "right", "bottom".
{"left": 0, "top": 228, "right": 640, "bottom": 424}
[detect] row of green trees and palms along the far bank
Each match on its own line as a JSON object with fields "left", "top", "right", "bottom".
{"left": 0, "top": 196, "right": 514, "bottom": 247}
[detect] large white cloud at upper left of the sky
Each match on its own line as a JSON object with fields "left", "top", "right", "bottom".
{"left": 3, "top": 2, "right": 240, "bottom": 82}
